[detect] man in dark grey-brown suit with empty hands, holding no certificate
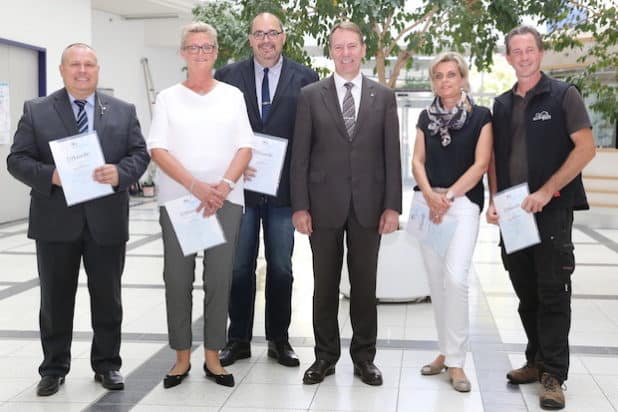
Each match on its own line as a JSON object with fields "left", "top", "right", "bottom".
{"left": 290, "top": 22, "right": 401, "bottom": 385}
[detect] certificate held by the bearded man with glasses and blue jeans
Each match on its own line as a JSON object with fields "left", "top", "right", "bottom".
{"left": 244, "top": 133, "right": 288, "bottom": 196}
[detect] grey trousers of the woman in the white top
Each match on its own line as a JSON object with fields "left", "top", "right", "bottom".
{"left": 159, "top": 201, "right": 243, "bottom": 350}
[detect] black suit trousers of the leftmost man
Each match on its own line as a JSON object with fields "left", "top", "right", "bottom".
{"left": 36, "top": 226, "right": 126, "bottom": 376}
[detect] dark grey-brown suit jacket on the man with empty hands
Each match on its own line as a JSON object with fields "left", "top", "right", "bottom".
{"left": 291, "top": 76, "right": 401, "bottom": 228}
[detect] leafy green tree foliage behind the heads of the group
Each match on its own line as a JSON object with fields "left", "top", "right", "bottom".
{"left": 191, "top": 0, "right": 618, "bottom": 121}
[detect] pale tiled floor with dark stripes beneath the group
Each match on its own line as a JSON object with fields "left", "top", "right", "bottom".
{"left": 0, "top": 200, "right": 618, "bottom": 412}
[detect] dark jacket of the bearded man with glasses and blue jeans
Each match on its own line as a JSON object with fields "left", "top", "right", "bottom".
{"left": 215, "top": 57, "right": 318, "bottom": 207}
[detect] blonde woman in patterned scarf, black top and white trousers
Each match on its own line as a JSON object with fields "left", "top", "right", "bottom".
{"left": 412, "top": 52, "right": 492, "bottom": 392}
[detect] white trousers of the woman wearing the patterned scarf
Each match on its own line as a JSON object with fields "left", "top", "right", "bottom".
{"left": 414, "top": 192, "right": 480, "bottom": 368}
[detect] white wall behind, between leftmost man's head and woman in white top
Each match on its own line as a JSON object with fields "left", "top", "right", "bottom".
{"left": 92, "top": 10, "right": 184, "bottom": 136}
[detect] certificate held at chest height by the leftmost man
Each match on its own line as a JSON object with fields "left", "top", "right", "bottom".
{"left": 49, "top": 131, "right": 114, "bottom": 206}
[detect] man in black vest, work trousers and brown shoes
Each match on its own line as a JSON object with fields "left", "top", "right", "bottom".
{"left": 487, "top": 26, "right": 595, "bottom": 409}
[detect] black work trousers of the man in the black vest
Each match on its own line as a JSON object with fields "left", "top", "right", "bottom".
{"left": 502, "top": 209, "right": 575, "bottom": 382}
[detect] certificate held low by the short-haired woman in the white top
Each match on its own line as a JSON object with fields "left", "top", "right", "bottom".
{"left": 165, "top": 195, "right": 225, "bottom": 256}
